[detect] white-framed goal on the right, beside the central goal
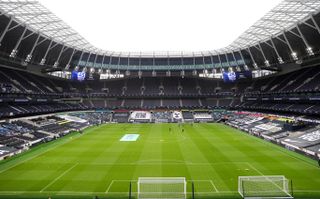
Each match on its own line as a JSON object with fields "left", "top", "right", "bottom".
{"left": 238, "top": 176, "right": 293, "bottom": 199}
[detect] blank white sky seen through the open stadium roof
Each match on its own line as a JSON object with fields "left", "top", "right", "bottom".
{"left": 39, "top": 0, "right": 282, "bottom": 52}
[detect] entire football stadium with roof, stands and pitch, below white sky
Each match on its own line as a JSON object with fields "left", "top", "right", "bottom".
{"left": 0, "top": 0, "right": 320, "bottom": 199}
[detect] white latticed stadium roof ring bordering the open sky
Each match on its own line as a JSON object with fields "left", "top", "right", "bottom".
{"left": 0, "top": 0, "right": 320, "bottom": 57}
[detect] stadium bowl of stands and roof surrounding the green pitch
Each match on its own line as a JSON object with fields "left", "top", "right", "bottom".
{"left": 0, "top": 0, "right": 320, "bottom": 169}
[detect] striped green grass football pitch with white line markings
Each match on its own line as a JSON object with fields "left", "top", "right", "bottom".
{"left": 0, "top": 123, "right": 320, "bottom": 199}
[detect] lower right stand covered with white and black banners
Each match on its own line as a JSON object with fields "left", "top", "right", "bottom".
{"left": 226, "top": 112, "right": 320, "bottom": 158}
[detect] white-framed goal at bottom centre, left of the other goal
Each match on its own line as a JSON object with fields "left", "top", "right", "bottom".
{"left": 138, "top": 177, "right": 187, "bottom": 199}
